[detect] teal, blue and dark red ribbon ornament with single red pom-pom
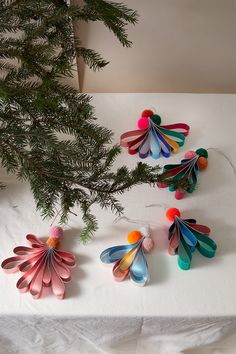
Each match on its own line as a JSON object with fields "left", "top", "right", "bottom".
{"left": 166, "top": 208, "right": 217, "bottom": 270}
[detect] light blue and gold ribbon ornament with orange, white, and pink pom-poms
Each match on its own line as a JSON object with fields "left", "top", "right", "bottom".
{"left": 100, "top": 227, "right": 154, "bottom": 286}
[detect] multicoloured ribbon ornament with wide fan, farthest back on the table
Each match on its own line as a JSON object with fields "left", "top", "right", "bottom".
{"left": 120, "top": 110, "right": 190, "bottom": 159}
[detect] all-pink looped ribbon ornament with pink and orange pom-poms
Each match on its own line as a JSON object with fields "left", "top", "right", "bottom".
{"left": 2, "top": 226, "right": 75, "bottom": 300}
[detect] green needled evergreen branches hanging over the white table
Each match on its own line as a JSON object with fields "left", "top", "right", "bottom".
{"left": 0, "top": 0, "right": 171, "bottom": 241}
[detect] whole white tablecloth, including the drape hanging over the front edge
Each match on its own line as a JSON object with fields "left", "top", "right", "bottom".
{"left": 0, "top": 94, "right": 236, "bottom": 354}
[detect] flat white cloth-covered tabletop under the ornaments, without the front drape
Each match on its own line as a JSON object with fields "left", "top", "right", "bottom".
{"left": 0, "top": 94, "right": 236, "bottom": 317}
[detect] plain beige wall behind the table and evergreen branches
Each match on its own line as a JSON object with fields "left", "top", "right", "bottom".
{"left": 75, "top": 0, "right": 236, "bottom": 93}
